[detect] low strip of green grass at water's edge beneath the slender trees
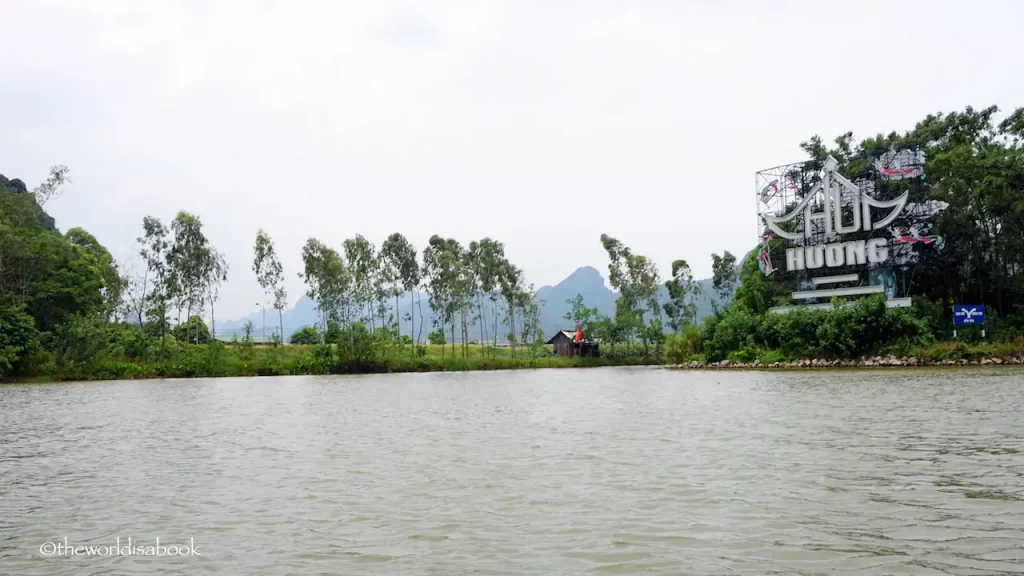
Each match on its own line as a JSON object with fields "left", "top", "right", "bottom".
{"left": 7, "top": 342, "right": 657, "bottom": 381}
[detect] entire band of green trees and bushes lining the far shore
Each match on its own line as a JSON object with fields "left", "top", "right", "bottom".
{"left": 0, "top": 103, "right": 1024, "bottom": 379}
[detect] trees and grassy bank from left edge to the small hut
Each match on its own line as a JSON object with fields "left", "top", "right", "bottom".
{"left": 0, "top": 166, "right": 657, "bottom": 379}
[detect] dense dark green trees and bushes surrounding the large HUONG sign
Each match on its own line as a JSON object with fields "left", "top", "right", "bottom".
{"left": 667, "top": 108, "right": 1024, "bottom": 365}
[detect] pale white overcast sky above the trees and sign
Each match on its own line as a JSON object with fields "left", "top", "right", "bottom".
{"left": 0, "top": 0, "right": 1024, "bottom": 319}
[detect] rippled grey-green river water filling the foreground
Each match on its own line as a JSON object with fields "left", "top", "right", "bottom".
{"left": 0, "top": 368, "right": 1024, "bottom": 575}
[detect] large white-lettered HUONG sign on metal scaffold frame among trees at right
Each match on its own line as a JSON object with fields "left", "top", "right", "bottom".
{"left": 757, "top": 150, "right": 948, "bottom": 312}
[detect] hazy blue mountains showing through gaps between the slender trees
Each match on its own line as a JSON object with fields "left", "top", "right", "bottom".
{"left": 217, "top": 266, "right": 712, "bottom": 340}
